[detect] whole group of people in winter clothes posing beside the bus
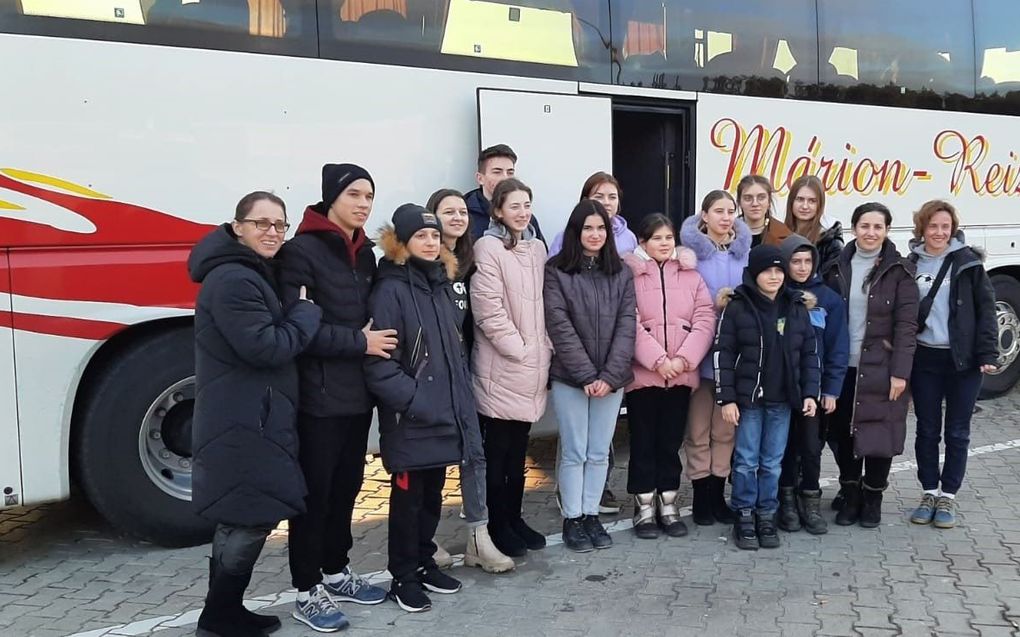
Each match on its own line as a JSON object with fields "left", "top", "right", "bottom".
{"left": 189, "top": 145, "right": 997, "bottom": 636}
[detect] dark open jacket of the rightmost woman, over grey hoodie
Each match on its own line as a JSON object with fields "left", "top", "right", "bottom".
{"left": 907, "top": 237, "right": 999, "bottom": 372}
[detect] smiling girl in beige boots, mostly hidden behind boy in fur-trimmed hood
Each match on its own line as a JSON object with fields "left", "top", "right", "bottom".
{"left": 425, "top": 189, "right": 515, "bottom": 573}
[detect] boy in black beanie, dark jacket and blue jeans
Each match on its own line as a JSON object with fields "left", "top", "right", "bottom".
{"left": 713, "top": 246, "right": 820, "bottom": 550}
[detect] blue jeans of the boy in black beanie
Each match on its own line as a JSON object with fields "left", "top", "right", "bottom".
{"left": 730, "top": 403, "right": 789, "bottom": 516}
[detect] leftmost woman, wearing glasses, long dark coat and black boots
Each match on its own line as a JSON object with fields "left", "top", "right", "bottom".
{"left": 188, "top": 192, "right": 321, "bottom": 637}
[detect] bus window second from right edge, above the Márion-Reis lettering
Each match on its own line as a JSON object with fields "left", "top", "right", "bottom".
{"left": 818, "top": 0, "right": 974, "bottom": 103}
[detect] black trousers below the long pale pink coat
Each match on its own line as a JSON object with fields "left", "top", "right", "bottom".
{"left": 478, "top": 414, "right": 531, "bottom": 529}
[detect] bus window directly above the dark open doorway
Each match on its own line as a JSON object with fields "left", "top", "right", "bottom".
{"left": 611, "top": 0, "right": 818, "bottom": 97}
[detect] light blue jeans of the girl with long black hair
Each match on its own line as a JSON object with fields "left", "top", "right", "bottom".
{"left": 551, "top": 380, "right": 623, "bottom": 518}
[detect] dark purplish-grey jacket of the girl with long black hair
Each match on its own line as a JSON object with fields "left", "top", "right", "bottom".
{"left": 544, "top": 259, "right": 638, "bottom": 391}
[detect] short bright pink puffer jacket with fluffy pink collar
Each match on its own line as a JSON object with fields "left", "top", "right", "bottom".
{"left": 623, "top": 248, "right": 716, "bottom": 391}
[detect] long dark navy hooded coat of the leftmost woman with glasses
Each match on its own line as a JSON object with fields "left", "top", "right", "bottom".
{"left": 188, "top": 223, "right": 321, "bottom": 526}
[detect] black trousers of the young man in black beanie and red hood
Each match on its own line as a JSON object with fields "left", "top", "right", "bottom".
{"left": 288, "top": 413, "right": 372, "bottom": 591}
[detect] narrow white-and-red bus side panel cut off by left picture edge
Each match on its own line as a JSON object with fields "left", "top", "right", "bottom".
{"left": 0, "top": 250, "right": 21, "bottom": 509}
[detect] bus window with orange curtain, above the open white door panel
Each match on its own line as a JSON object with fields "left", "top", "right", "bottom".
{"left": 319, "top": 0, "right": 609, "bottom": 82}
